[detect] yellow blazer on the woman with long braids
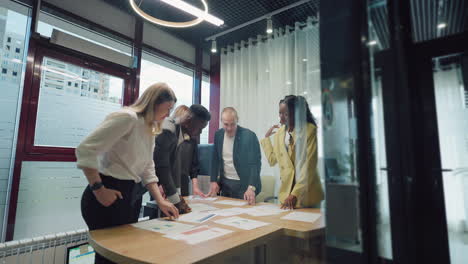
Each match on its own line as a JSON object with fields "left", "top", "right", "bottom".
{"left": 260, "top": 123, "right": 324, "bottom": 208}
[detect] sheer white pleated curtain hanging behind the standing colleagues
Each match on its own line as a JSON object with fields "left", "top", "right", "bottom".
{"left": 220, "top": 20, "right": 323, "bottom": 194}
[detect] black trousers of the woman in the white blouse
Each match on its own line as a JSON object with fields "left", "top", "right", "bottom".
{"left": 81, "top": 174, "right": 141, "bottom": 264}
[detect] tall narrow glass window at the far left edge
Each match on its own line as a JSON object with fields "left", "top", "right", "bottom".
{"left": 0, "top": 1, "right": 31, "bottom": 238}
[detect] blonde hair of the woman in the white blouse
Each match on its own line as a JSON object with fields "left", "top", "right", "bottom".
{"left": 128, "top": 82, "right": 177, "bottom": 134}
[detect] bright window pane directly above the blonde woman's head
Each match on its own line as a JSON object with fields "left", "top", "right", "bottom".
{"left": 139, "top": 52, "right": 193, "bottom": 108}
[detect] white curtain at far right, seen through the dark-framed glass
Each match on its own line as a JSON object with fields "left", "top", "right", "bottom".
{"left": 434, "top": 67, "right": 468, "bottom": 232}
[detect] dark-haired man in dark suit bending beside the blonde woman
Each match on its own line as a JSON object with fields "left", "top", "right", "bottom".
{"left": 154, "top": 105, "right": 211, "bottom": 213}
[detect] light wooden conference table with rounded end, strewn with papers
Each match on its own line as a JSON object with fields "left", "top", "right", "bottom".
{"left": 89, "top": 197, "right": 325, "bottom": 263}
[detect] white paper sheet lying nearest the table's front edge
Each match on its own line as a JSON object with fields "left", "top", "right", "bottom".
{"left": 164, "top": 225, "right": 233, "bottom": 245}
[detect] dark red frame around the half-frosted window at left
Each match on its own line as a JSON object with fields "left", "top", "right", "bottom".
{"left": 24, "top": 36, "right": 133, "bottom": 161}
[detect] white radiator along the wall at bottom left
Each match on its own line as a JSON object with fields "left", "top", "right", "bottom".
{"left": 0, "top": 229, "right": 88, "bottom": 264}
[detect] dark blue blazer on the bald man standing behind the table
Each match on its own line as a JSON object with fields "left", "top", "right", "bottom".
{"left": 210, "top": 126, "right": 262, "bottom": 194}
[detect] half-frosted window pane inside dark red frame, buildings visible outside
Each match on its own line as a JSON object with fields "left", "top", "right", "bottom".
{"left": 34, "top": 57, "right": 124, "bottom": 148}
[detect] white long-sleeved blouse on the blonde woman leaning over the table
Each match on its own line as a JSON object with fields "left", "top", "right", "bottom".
{"left": 75, "top": 109, "right": 158, "bottom": 185}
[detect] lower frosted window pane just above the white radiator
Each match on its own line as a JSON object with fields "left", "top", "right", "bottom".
{"left": 14, "top": 161, "right": 87, "bottom": 239}
